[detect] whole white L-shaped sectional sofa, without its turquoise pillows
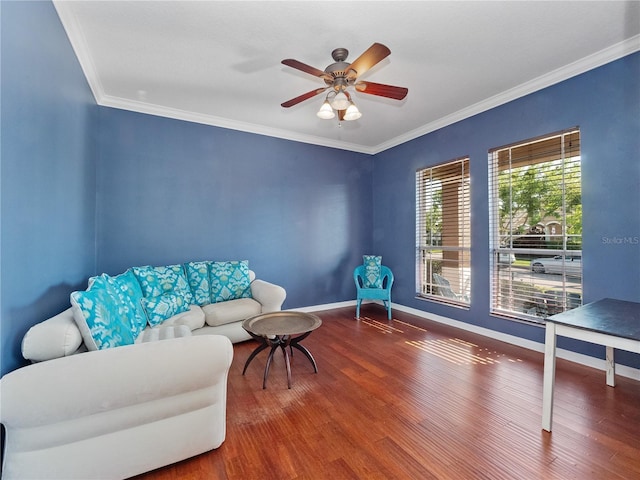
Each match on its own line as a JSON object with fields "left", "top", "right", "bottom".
{"left": 0, "top": 262, "right": 286, "bottom": 479}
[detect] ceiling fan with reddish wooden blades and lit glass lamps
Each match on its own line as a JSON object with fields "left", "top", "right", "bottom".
{"left": 281, "top": 43, "right": 409, "bottom": 121}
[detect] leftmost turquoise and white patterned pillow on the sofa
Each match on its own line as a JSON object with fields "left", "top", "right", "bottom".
{"left": 71, "top": 277, "right": 134, "bottom": 350}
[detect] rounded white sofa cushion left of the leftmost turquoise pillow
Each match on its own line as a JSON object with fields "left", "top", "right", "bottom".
{"left": 22, "top": 308, "right": 82, "bottom": 362}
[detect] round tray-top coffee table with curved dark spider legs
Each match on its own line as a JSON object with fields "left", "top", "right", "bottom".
{"left": 242, "top": 311, "right": 322, "bottom": 388}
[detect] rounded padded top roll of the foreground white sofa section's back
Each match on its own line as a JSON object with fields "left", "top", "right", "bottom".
{"left": 0, "top": 335, "right": 233, "bottom": 427}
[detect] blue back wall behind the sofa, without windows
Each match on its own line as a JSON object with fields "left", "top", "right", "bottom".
{"left": 98, "top": 108, "right": 373, "bottom": 308}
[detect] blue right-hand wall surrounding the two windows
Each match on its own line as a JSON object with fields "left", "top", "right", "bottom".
{"left": 373, "top": 53, "right": 640, "bottom": 367}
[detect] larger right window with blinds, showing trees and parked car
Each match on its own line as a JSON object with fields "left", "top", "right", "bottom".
{"left": 489, "top": 128, "right": 582, "bottom": 322}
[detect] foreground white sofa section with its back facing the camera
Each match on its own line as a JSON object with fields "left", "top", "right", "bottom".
{"left": 0, "top": 335, "right": 233, "bottom": 480}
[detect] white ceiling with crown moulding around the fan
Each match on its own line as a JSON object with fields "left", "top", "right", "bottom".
{"left": 54, "top": 0, "right": 640, "bottom": 154}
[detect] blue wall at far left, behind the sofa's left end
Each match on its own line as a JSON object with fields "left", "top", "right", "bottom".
{"left": 0, "top": 2, "right": 97, "bottom": 373}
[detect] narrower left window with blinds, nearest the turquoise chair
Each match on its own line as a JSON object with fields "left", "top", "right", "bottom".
{"left": 416, "top": 158, "right": 471, "bottom": 305}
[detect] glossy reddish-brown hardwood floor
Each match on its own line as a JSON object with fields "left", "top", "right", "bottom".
{"left": 132, "top": 305, "right": 640, "bottom": 480}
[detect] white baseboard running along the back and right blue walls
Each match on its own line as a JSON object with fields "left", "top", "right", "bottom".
{"left": 294, "top": 300, "right": 640, "bottom": 381}
